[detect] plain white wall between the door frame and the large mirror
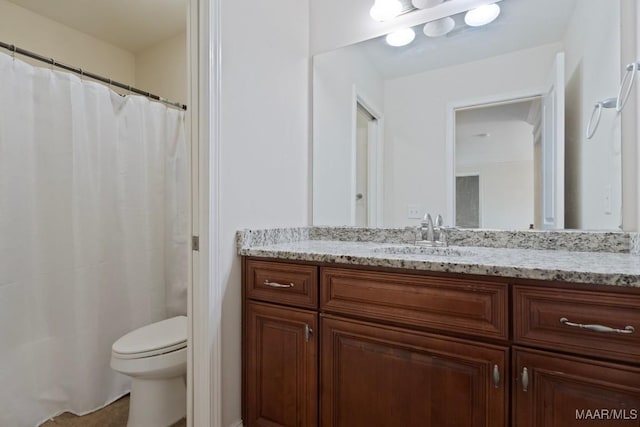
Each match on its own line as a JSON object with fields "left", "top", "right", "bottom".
{"left": 219, "top": 0, "right": 310, "bottom": 426}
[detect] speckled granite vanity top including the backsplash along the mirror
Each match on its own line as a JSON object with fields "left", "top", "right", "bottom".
{"left": 238, "top": 227, "right": 640, "bottom": 287}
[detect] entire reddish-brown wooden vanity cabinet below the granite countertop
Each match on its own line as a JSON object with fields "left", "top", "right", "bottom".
{"left": 243, "top": 258, "right": 640, "bottom": 427}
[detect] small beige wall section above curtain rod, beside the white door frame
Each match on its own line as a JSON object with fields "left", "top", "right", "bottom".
{"left": 135, "top": 33, "right": 187, "bottom": 104}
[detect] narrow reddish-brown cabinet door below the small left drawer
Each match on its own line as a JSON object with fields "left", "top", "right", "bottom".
{"left": 245, "top": 302, "right": 318, "bottom": 427}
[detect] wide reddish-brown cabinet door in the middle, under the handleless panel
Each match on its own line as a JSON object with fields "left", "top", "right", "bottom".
{"left": 320, "top": 316, "right": 508, "bottom": 427}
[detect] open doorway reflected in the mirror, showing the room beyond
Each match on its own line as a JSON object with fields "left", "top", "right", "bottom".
{"left": 455, "top": 96, "right": 541, "bottom": 229}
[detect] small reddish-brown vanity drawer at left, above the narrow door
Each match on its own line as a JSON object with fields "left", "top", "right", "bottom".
{"left": 245, "top": 260, "right": 318, "bottom": 308}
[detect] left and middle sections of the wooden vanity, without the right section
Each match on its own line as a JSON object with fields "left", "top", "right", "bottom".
{"left": 243, "top": 258, "right": 509, "bottom": 427}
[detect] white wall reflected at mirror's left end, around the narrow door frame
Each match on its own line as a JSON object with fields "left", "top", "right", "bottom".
{"left": 313, "top": 47, "right": 384, "bottom": 225}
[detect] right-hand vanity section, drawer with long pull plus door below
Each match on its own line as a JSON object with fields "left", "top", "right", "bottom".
{"left": 512, "top": 285, "right": 640, "bottom": 427}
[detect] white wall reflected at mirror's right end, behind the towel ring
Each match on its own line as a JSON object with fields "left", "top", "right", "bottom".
{"left": 564, "top": 0, "right": 622, "bottom": 229}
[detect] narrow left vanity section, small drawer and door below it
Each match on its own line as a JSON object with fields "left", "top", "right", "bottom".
{"left": 242, "top": 260, "right": 318, "bottom": 427}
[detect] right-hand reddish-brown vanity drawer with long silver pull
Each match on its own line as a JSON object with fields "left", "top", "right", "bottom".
{"left": 513, "top": 286, "right": 640, "bottom": 363}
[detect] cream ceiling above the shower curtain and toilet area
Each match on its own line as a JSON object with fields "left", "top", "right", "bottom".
{"left": 9, "top": 0, "right": 187, "bottom": 53}
